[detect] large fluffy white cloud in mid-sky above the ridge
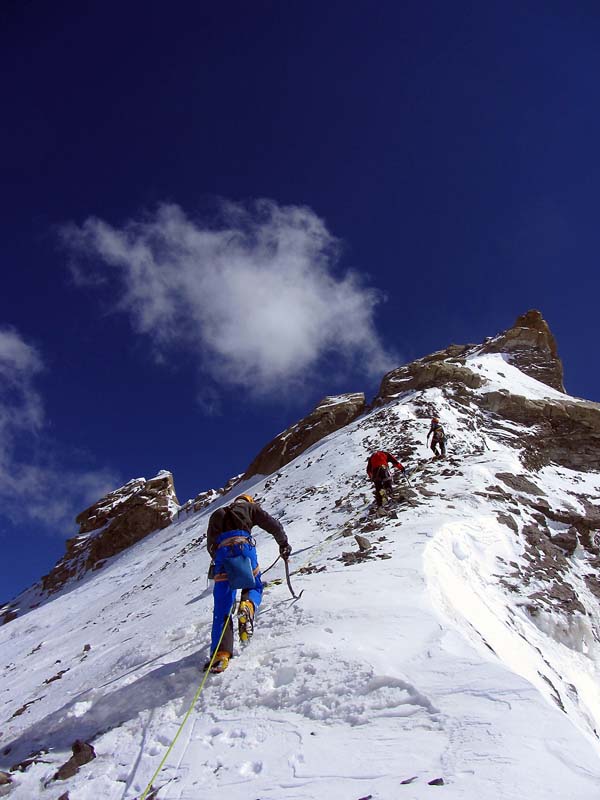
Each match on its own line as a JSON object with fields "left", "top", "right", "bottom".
{"left": 63, "top": 200, "right": 393, "bottom": 394}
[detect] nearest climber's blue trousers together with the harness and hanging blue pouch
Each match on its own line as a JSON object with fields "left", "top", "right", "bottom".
{"left": 211, "top": 530, "right": 263, "bottom": 653}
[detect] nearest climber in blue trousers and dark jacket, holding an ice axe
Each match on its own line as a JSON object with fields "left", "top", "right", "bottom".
{"left": 204, "top": 494, "right": 292, "bottom": 672}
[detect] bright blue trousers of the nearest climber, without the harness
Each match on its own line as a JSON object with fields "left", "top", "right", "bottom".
{"left": 210, "top": 542, "right": 263, "bottom": 653}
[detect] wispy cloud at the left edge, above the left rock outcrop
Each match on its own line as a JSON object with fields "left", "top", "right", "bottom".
{"left": 0, "top": 328, "right": 117, "bottom": 533}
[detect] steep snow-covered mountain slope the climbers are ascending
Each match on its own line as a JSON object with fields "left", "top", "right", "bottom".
{"left": 0, "top": 354, "right": 600, "bottom": 800}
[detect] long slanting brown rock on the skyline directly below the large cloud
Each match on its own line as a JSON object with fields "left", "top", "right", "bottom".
{"left": 243, "top": 392, "right": 365, "bottom": 479}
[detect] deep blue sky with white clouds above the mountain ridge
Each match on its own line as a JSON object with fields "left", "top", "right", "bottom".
{"left": 0, "top": 0, "right": 600, "bottom": 599}
